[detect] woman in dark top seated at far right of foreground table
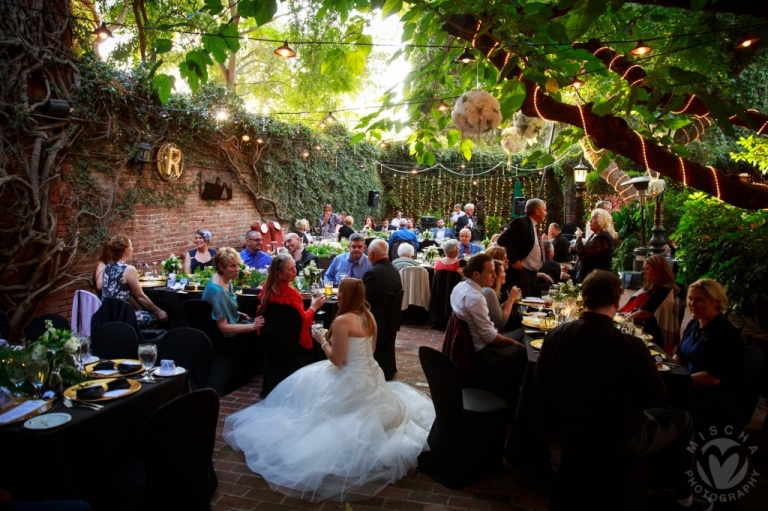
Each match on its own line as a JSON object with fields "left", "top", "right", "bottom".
{"left": 675, "top": 279, "right": 744, "bottom": 431}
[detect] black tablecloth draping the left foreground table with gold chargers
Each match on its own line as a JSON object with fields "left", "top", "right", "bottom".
{"left": 0, "top": 375, "right": 187, "bottom": 502}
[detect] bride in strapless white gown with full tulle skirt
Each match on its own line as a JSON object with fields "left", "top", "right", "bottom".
{"left": 223, "top": 278, "right": 435, "bottom": 502}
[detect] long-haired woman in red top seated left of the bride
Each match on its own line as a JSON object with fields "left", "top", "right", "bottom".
{"left": 259, "top": 254, "right": 325, "bottom": 365}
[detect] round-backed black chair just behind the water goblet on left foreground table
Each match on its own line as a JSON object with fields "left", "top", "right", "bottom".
{"left": 157, "top": 327, "right": 213, "bottom": 390}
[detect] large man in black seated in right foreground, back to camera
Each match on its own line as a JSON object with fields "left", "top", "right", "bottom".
{"left": 534, "top": 270, "right": 711, "bottom": 510}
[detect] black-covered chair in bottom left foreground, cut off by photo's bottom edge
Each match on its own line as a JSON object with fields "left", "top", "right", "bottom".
{"left": 142, "top": 389, "right": 219, "bottom": 511}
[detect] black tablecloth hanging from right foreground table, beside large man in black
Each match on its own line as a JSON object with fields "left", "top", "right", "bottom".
{"left": 504, "top": 334, "right": 691, "bottom": 472}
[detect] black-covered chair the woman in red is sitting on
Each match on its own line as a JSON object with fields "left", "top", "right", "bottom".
{"left": 261, "top": 303, "right": 304, "bottom": 397}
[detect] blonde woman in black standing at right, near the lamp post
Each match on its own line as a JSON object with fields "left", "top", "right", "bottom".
{"left": 574, "top": 209, "right": 616, "bottom": 282}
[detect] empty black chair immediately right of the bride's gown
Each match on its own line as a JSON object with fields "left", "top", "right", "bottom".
{"left": 419, "top": 346, "right": 509, "bottom": 489}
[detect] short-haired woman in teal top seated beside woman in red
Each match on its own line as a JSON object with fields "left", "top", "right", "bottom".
{"left": 202, "top": 247, "right": 264, "bottom": 336}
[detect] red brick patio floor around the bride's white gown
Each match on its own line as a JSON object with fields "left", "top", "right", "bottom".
{"left": 212, "top": 318, "right": 768, "bottom": 511}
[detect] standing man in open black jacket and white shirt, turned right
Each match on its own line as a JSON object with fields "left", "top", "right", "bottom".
{"left": 497, "top": 199, "right": 547, "bottom": 296}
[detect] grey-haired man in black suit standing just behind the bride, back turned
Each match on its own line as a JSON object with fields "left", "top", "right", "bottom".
{"left": 363, "top": 239, "right": 403, "bottom": 381}
